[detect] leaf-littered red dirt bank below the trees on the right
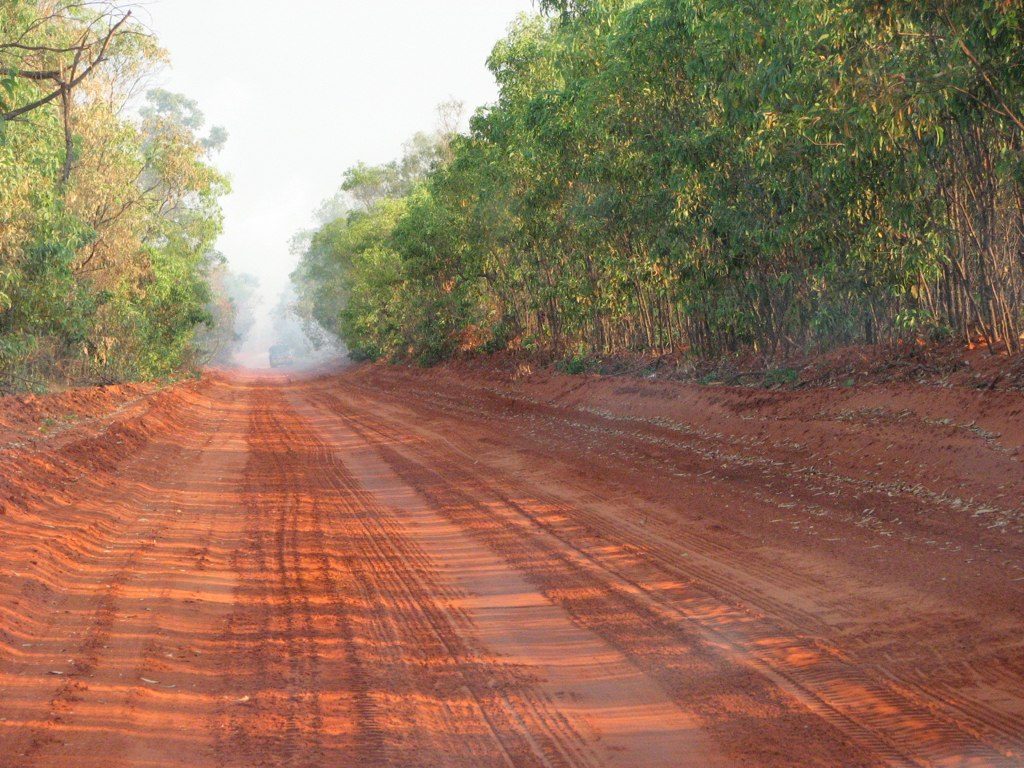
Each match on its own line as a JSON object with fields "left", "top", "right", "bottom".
{"left": 355, "top": 365, "right": 1024, "bottom": 534}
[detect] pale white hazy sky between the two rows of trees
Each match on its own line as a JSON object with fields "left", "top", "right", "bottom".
{"left": 142, "top": 0, "right": 534, "bottom": 301}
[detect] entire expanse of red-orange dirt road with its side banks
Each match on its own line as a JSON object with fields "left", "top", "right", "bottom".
{"left": 0, "top": 367, "right": 1024, "bottom": 768}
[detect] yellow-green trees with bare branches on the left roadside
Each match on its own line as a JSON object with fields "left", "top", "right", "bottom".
{"left": 0, "top": 0, "right": 234, "bottom": 389}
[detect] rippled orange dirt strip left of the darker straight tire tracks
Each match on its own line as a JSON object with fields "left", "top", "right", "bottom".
{"left": 0, "top": 382, "right": 247, "bottom": 768}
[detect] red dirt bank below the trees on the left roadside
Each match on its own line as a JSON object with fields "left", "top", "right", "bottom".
{"left": 0, "top": 382, "right": 216, "bottom": 643}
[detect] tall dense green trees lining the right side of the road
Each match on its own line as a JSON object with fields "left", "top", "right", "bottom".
{"left": 295, "top": 0, "right": 1024, "bottom": 361}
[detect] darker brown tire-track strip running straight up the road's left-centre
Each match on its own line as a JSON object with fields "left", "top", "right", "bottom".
{"left": 216, "top": 396, "right": 344, "bottom": 766}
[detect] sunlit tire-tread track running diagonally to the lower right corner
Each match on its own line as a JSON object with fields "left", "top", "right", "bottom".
{"left": 315, "top": 382, "right": 1016, "bottom": 766}
